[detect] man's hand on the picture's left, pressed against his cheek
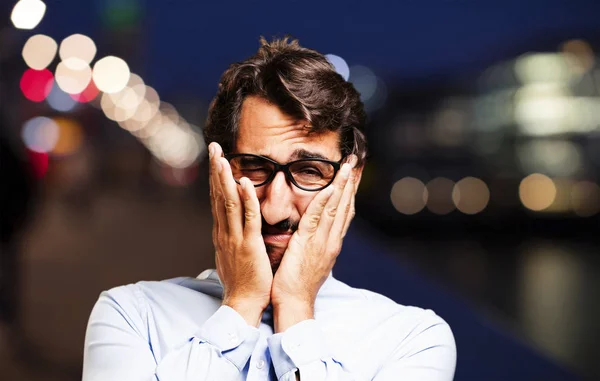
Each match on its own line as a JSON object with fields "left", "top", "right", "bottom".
{"left": 208, "top": 143, "right": 273, "bottom": 327}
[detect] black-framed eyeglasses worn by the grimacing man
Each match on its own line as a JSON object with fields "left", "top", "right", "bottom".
{"left": 225, "top": 153, "right": 344, "bottom": 192}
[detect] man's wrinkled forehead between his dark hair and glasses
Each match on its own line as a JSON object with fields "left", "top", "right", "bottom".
{"left": 235, "top": 96, "right": 341, "bottom": 162}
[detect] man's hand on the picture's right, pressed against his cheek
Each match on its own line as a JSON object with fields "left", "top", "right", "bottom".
{"left": 271, "top": 156, "right": 360, "bottom": 332}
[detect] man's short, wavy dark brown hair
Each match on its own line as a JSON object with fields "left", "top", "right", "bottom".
{"left": 204, "top": 37, "right": 367, "bottom": 165}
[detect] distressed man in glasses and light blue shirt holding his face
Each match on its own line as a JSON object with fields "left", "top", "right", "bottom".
{"left": 83, "top": 39, "right": 456, "bottom": 381}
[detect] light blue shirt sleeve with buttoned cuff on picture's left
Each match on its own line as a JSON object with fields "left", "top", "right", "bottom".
{"left": 82, "top": 285, "right": 259, "bottom": 381}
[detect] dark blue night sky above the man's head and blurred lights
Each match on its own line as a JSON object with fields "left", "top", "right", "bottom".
{"left": 34, "top": 0, "right": 600, "bottom": 96}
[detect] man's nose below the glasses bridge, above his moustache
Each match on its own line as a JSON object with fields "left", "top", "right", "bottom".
{"left": 260, "top": 172, "right": 293, "bottom": 225}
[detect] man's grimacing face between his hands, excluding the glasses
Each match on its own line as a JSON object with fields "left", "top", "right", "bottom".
{"left": 235, "top": 97, "right": 342, "bottom": 272}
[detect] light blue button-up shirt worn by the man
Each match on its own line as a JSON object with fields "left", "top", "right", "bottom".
{"left": 83, "top": 270, "right": 456, "bottom": 381}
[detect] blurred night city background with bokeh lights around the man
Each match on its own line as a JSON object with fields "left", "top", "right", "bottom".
{"left": 0, "top": 0, "right": 600, "bottom": 381}
